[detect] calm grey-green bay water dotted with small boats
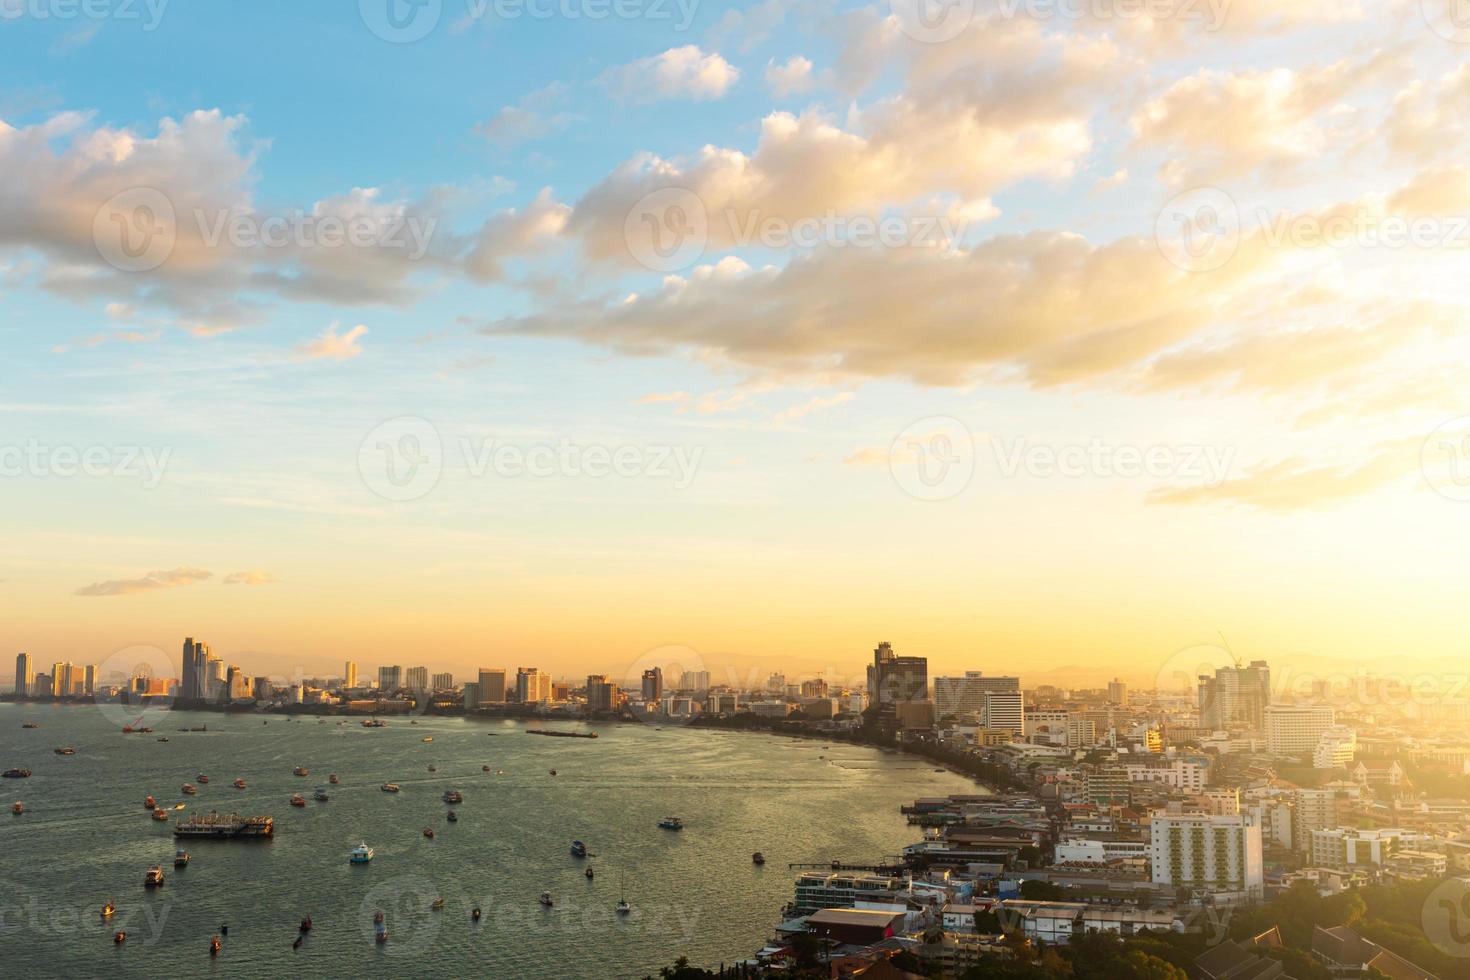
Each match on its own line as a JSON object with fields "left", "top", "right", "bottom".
{"left": 0, "top": 705, "right": 982, "bottom": 980}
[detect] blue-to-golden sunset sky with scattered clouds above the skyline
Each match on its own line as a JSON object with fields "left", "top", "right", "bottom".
{"left": 0, "top": 0, "right": 1470, "bottom": 685}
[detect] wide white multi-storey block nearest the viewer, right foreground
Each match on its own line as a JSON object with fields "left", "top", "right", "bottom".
{"left": 1148, "top": 811, "right": 1266, "bottom": 901}
